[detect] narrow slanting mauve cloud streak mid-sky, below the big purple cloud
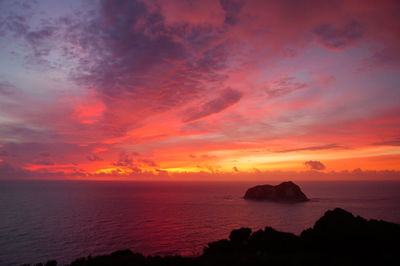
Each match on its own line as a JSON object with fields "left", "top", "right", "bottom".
{"left": 183, "top": 88, "right": 243, "bottom": 122}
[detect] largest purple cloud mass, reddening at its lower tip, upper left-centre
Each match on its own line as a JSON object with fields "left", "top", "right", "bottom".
{"left": 54, "top": 1, "right": 233, "bottom": 137}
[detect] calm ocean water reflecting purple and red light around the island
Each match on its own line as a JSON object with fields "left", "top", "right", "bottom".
{"left": 0, "top": 181, "right": 400, "bottom": 265}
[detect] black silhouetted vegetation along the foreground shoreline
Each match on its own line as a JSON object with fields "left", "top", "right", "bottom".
{"left": 23, "top": 209, "right": 400, "bottom": 266}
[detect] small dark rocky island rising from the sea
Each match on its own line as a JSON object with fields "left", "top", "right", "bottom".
{"left": 244, "top": 181, "right": 309, "bottom": 202}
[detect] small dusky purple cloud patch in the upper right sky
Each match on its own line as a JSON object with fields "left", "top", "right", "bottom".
{"left": 314, "top": 21, "right": 364, "bottom": 49}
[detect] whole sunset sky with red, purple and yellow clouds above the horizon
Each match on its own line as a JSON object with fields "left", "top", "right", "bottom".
{"left": 0, "top": 0, "right": 400, "bottom": 180}
